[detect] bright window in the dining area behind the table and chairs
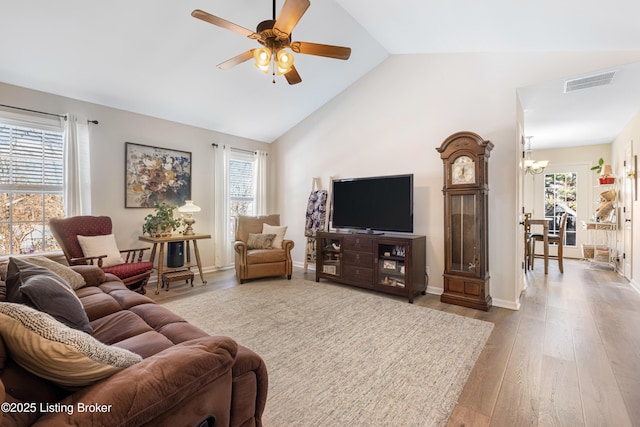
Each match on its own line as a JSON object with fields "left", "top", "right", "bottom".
{"left": 544, "top": 172, "right": 578, "bottom": 246}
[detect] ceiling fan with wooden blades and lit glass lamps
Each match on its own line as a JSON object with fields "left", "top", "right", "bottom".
{"left": 191, "top": 0, "right": 351, "bottom": 85}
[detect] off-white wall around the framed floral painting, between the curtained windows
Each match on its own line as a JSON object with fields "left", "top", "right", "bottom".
{"left": 0, "top": 83, "right": 275, "bottom": 269}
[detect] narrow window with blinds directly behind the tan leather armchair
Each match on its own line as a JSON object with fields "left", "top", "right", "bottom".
{"left": 229, "top": 151, "right": 256, "bottom": 241}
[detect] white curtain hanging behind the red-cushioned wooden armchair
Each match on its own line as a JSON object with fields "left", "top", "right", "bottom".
{"left": 64, "top": 114, "right": 91, "bottom": 217}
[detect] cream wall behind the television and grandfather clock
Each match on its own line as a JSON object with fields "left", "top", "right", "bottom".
{"left": 273, "top": 52, "right": 640, "bottom": 308}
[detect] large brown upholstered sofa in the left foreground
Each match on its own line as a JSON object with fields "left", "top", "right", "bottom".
{"left": 0, "top": 262, "right": 267, "bottom": 427}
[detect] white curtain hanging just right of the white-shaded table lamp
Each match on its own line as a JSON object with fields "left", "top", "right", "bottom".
{"left": 213, "top": 145, "right": 234, "bottom": 268}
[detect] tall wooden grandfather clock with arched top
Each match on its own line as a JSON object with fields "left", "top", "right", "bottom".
{"left": 437, "top": 132, "right": 493, "bottom": 311}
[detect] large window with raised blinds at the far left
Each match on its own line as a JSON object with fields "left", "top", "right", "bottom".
{"left": 0, "top": 117, "right": 64, "bottom": 254}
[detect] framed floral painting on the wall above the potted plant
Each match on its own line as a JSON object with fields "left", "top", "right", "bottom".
{"left": 124, "top": 142, "right": 191, "bottom": 208}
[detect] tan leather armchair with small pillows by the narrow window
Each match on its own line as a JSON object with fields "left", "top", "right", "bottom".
{"left": 233, "top": 215, "right": 294, "bottom": 283}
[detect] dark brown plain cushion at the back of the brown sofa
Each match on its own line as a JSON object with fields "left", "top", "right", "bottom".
{"left": 7, "top": 257, "right": 92, "bottom": 333}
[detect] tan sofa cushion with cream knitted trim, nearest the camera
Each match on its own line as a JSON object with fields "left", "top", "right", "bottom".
{"left": 0, "top": 302, "right": 142, "bottom": 387}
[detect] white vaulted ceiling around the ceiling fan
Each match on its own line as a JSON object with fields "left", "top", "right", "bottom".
{"left": 0, "top": 0, "right": 640, "bottom": 142}
